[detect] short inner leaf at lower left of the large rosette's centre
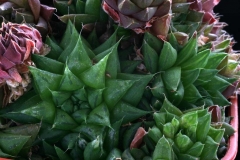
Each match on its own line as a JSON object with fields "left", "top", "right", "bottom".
{"left": 52, "top": 109, "right": 78, "bottom": 130}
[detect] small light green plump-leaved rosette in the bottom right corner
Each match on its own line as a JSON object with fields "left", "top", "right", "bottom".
{"left": 122, "top": 99, "right": 233, "bottom": 160}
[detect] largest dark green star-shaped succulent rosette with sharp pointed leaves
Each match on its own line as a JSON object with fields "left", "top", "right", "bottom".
{"left": 1, "top": 22, "right": 152, "bottom": 159}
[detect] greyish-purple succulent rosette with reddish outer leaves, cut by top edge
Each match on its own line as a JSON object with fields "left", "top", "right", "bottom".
{"left": 102, "top": 0, "right": 171, "bottom": 39}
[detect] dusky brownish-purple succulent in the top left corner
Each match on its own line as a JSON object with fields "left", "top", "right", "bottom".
{"left": 0, "top": 0, "right": 55, "bottom": 37}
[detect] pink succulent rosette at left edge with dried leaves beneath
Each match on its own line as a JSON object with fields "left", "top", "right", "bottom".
{"left": 0, "top": 23, "right": 43, "bottom": 105}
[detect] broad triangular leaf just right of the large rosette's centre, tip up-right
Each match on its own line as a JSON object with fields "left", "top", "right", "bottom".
{"left": 103, "top": 79, "right": 135, "bottom": 110}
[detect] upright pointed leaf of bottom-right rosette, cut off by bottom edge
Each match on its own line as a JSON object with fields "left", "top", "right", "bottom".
{"left": 152, "top": 136, "right": 174, "bottom": 160}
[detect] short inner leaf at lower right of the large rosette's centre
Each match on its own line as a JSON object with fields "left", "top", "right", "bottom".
{"left": 87, "top": 103, "right": 111, "bottom": 127}
